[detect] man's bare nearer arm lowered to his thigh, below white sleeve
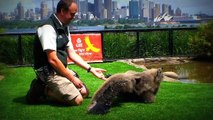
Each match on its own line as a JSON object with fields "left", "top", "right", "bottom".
{"left": 46, "top": 50, "right": 83, "bottom": 88}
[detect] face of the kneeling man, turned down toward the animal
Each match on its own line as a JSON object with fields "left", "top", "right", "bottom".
{"left": 64, "top": 3, "right": 78, "bottom": 25}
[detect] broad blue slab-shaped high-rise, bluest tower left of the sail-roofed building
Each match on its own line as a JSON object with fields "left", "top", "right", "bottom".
{"left": 129, "top": 0, "right": 139, "bottom": 19}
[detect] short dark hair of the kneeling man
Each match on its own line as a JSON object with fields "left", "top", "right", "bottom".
{"left": 56, "top": 0, "right": 75, "bottom": 13}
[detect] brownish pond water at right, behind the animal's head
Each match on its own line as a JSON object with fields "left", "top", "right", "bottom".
{"left": 146, "top": 61, "right": 213, "bottom": 83}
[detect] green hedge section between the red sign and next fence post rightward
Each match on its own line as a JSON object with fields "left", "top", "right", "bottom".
{"left": 103, "top": 33, "right": 136, "bottom": 59}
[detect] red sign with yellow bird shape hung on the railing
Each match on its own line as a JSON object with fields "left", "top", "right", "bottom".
{"left": 68, "top": 33, "right": 103, "bottom": 63}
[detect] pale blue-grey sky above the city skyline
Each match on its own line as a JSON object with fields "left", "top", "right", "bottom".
{"left": 0, "top": 0, "right": 213, "bottom": 15}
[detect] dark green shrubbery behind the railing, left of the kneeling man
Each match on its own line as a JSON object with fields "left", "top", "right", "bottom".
{"left": 0, "top": 36, "right": 33, "bottom": 64}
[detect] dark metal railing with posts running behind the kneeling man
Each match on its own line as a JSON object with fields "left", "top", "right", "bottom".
{"left": 0, "top": 27, "right": 197, "bottom": 64}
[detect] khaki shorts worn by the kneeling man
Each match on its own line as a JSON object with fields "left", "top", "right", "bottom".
{"left": 47, "top": 70, "right": 81, "bottom": 101}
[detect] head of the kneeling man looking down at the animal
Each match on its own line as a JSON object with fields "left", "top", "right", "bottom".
{"left": 56, "top": 0, "right": 78, "bottom": 25}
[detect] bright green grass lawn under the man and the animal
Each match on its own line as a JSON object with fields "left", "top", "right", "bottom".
{"left": 0, "top": 62, "right": 213, "bottom": 120}
